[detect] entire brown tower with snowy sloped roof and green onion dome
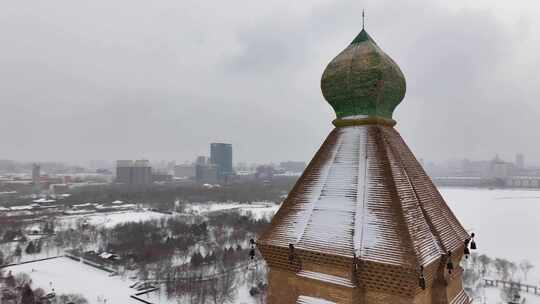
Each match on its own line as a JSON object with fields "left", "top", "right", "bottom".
{"left": 257, "top": 29, "right": 470, "bottom": 304}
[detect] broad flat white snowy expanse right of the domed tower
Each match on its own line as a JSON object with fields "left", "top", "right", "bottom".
{"left": 439, "top": 188, "right": 540, "bottom": 285}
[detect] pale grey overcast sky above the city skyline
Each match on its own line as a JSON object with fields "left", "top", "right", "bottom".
{"left": 0, "top": 0, "right": 540, "bottom": 166}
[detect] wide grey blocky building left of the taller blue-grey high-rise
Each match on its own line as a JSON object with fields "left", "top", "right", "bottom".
{"left": 116, "top": 160, "right": 152, "bottom": 186}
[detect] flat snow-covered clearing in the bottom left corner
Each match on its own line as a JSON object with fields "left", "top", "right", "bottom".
{"left": 6, "top": 257, "right": 140, "bottom": 304}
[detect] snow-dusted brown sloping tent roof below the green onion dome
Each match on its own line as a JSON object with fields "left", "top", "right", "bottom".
{"left": 259, "top": 125, "right": 469, "bottom": 269}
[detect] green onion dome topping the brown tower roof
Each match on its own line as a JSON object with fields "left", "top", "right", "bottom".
{"left": 321, "top": 29, "right": 406, "bottom": 121}
